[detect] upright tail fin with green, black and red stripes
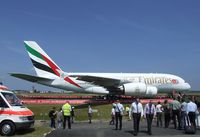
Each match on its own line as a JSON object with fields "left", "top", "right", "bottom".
{"left": 24, "top": 41, "right": 62, "bottom": 78}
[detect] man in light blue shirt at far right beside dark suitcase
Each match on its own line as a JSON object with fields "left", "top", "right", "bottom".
{"left": 186, "top": 98, "right": 197, "bottom": 131}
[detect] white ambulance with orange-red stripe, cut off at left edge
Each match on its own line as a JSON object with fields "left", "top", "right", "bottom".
{"left": 0, "top": 85, "right": 35, "bottom": 136}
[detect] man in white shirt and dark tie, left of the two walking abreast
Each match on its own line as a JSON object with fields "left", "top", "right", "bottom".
{"left": 129, "top": 98, "right": 143, "bottom": 136}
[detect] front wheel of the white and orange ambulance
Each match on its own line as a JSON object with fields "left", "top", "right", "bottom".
{"left": 0, "top": 121, "right": 15, "bottom": 136}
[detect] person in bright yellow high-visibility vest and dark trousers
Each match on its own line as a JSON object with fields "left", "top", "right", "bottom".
{"left": 62, "top": 101, "right": 71, "bottom": 129}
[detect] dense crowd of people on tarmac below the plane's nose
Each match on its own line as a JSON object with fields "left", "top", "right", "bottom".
{"left": 110, "top": 98, "right": 200, "bottom": 136}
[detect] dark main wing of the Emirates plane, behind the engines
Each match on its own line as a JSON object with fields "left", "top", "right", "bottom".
{"left": 70, "top": 75, "right": 121, "bottom": 87}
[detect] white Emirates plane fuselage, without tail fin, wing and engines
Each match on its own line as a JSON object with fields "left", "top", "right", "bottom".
{"left": 41, "top": 73, "right": 191, "bottom": 95}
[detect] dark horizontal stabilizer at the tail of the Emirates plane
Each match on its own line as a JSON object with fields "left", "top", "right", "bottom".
{"left": 9, "top": 73, "right": 53, "bottom": 82}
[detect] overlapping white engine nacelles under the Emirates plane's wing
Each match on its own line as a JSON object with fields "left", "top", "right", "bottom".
{"left": 120, "top": 83, "right": 157, "bottom": 96}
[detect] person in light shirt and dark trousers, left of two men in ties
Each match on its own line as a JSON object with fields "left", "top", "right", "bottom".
{"left": 115, "top": 100, "right": 124, "bottom": 130}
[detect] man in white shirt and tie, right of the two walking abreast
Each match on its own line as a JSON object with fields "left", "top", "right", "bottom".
{"left": 144, "top": 100, "right": 156, "bottom": 135}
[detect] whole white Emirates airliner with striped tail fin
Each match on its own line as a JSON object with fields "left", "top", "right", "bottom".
{"left": 11, "top": 41, "right": 191, "bottom": 96}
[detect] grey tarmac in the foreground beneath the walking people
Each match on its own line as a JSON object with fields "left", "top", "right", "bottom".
{"left": 45, "top": 120, "right": 200, "bottom": 137}
